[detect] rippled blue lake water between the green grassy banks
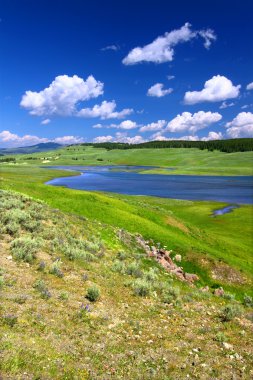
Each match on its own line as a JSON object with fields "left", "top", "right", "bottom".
{"left": 47, "top": 166, "right": 253, "bottom": 204}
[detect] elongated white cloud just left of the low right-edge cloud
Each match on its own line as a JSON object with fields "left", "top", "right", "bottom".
{"left": 166, "top": 111, "right": 222, "bottom": 133}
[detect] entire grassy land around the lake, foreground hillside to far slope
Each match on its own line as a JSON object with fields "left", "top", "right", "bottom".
{"left": 0, "top": 147, "right": 253, "bottom": 380}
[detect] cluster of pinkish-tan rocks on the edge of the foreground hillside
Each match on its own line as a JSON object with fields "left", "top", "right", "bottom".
{"left": 136, "top": 235, "right": 199, "bottom": 283}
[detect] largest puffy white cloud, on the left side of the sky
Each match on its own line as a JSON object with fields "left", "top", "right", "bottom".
{"left": 20, "top": 75, "right": 104, "bottom": 116}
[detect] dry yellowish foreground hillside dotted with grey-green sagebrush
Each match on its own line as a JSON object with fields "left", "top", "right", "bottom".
{"left": 0, "top": 191, "right": 253, "bottom": 380}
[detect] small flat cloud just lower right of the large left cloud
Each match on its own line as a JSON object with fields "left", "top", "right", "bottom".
{"left": 77, "top": 100, "right": 133, "bottom": 120}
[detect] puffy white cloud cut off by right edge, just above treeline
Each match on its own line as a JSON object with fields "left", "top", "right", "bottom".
{"left": 225, "top": 112, "right": 253, "bottom": 138}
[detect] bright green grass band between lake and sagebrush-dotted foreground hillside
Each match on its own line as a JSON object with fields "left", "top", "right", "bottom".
{"left": 1, "top": 166, "right": 253, "bottom": 296}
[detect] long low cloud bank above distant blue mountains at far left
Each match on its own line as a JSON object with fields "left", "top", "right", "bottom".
{"left": 0, "top": 131, "right": 84, "bottom": 148}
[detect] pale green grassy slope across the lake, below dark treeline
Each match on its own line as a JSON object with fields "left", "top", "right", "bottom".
{"left": 3, "top": 146, "right": 253, "bottom": 175}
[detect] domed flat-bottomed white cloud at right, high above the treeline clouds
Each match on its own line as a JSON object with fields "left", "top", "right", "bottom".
{"left": 184, "top": 75, "right": 241, "bottom": 104}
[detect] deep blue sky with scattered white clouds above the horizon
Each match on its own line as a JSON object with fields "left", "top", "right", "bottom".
{"left": 0, "top": 0, "right": 253, "bottom": 148}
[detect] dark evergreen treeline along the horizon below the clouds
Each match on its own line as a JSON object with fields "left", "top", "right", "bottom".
{"left": 77, "top": 138, "right": 253, "bottom": 153}
